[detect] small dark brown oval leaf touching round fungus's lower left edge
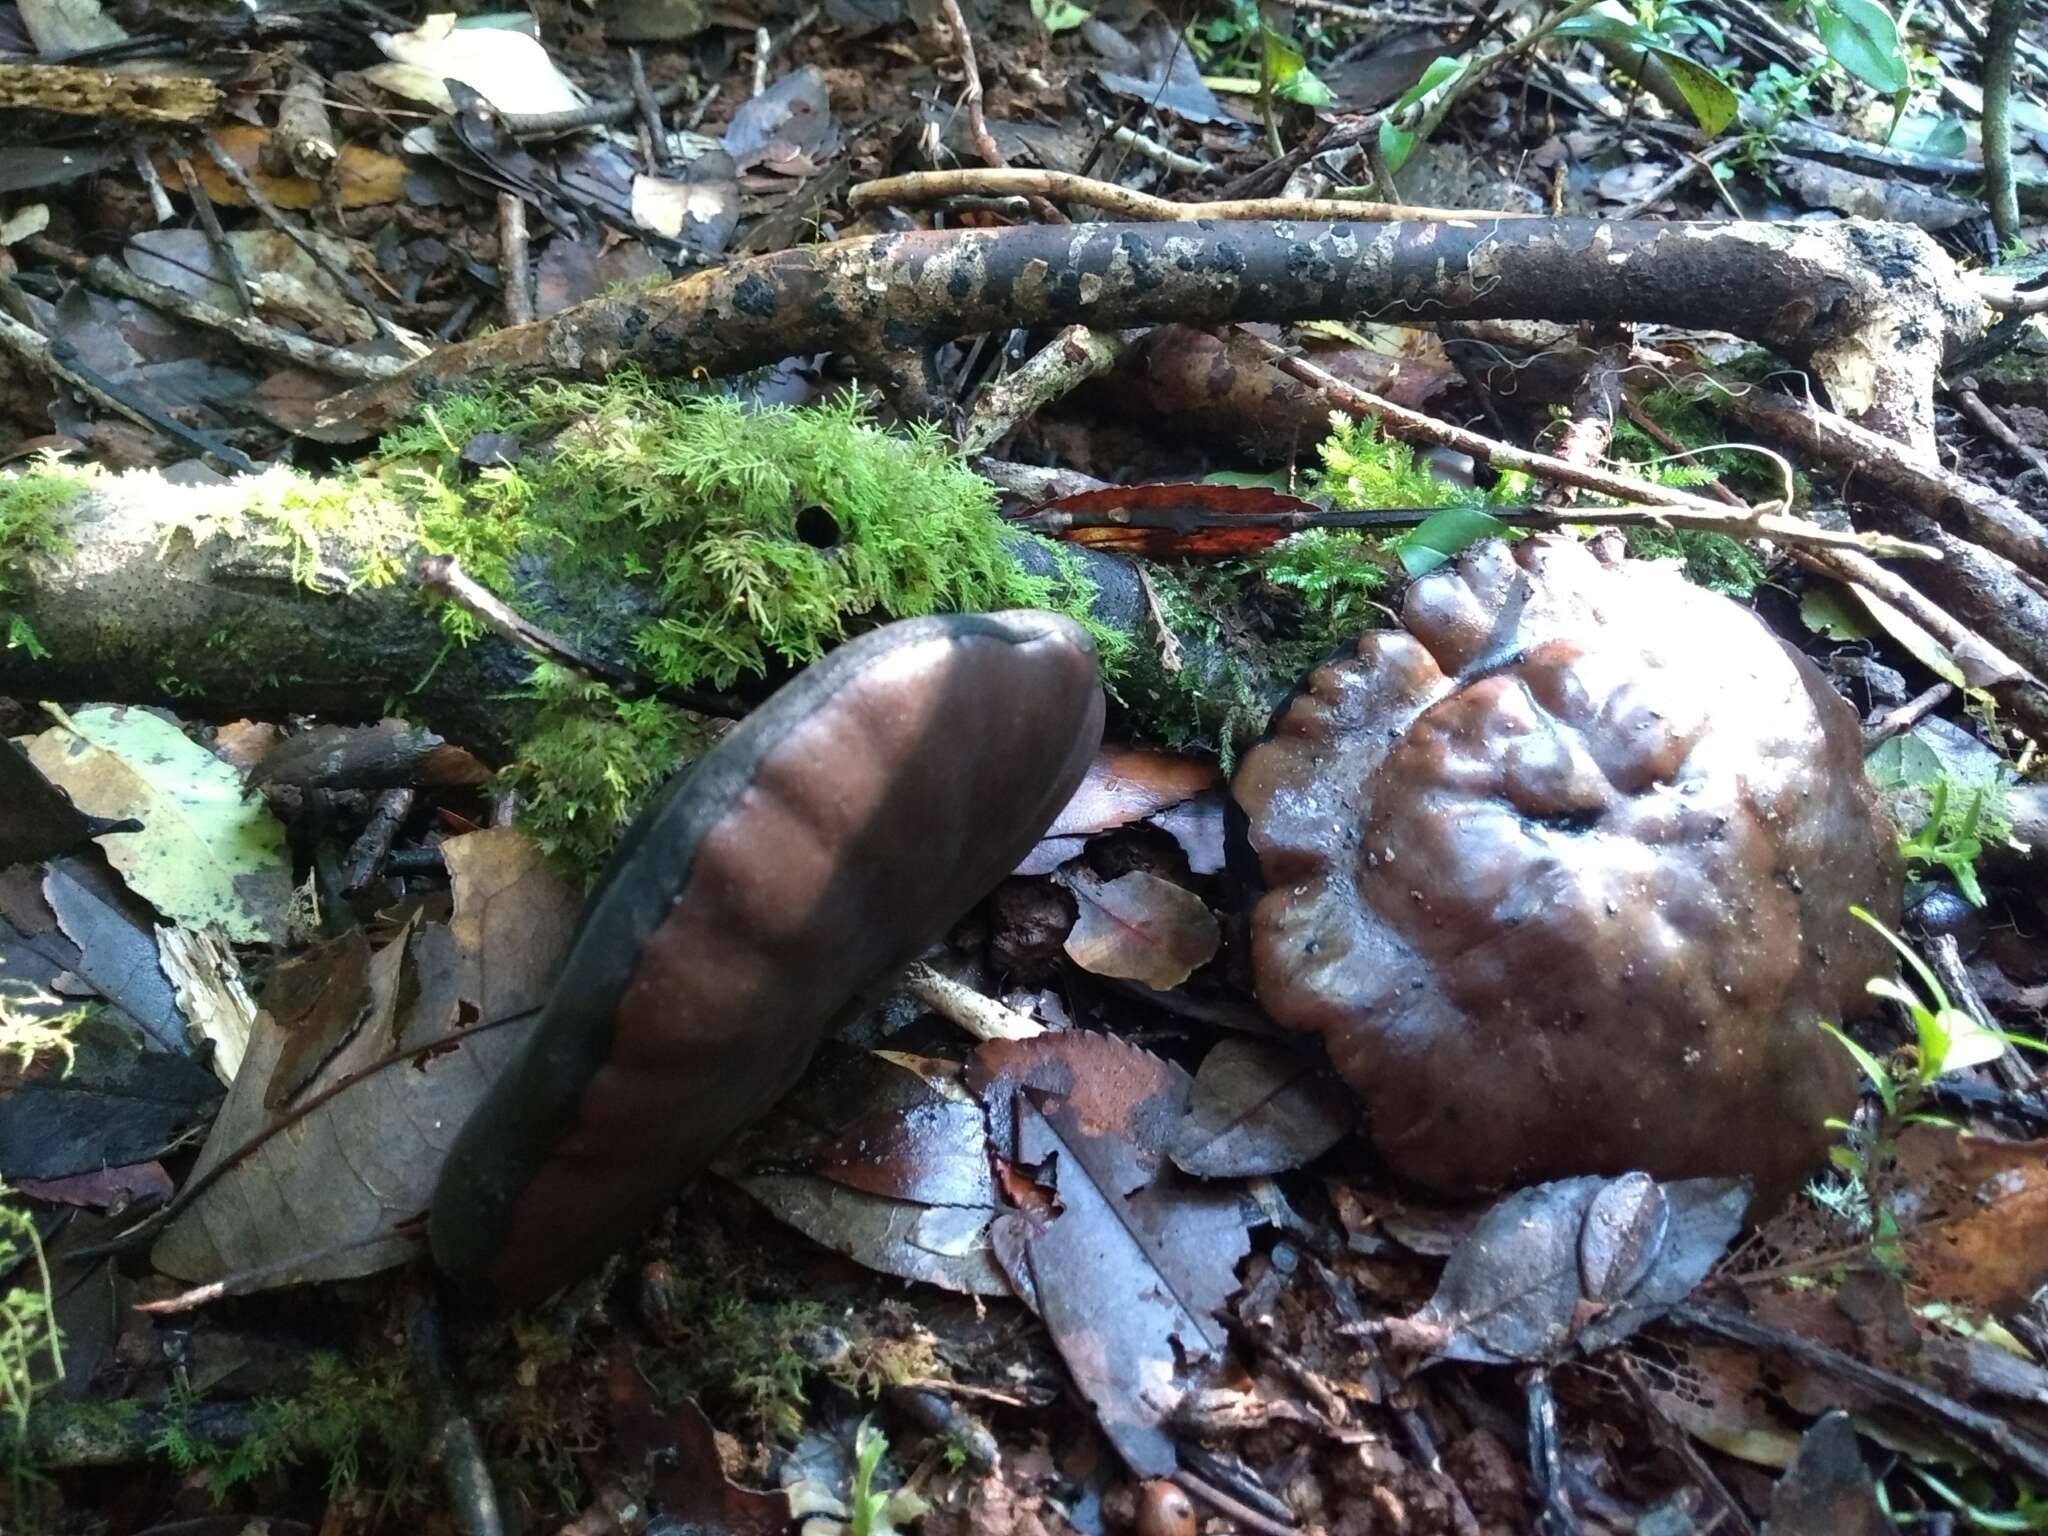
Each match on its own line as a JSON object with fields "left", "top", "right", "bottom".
{"left": 1171, "top": 1036, "right": 1358, "bottom": 1180}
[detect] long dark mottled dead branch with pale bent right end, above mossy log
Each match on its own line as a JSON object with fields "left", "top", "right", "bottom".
{"left": 315, "top": 219, "right": 1982, "bottom": 459}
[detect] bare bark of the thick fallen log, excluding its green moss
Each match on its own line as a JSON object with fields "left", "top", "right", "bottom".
{"left": 0, "top": 471, "right": 1151, "bottom": 758}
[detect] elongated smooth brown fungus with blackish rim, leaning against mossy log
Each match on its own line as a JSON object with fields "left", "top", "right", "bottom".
{"left": 430, "top": 612, "right": 1102, "bottom": 1303}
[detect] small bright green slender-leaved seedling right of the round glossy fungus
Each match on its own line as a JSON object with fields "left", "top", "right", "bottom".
{"left": 1815, "top": 907, "right": 2048, "bottom": 1268}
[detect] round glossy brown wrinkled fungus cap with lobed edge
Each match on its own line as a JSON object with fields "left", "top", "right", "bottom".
{"left": 1233, "top": 537, "right": 1901, "bottom": 1210}
